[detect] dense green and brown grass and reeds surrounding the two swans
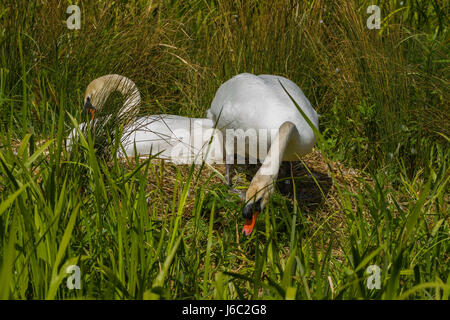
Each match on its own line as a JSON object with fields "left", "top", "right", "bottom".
{"left": 0, "top": 0, "right": 450, "bottom": 299}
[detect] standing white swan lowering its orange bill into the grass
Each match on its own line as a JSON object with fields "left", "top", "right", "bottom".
{"left": 207, "top": 73, "right": 319, "bottom": 236}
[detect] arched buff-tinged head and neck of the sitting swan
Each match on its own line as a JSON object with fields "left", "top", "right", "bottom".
{"left": 84, "top": 74, "right": 141, "bottom": 119}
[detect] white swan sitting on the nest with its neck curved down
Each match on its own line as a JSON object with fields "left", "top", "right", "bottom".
{"left": 66, "top": 74, "right": 223, "bottom": 164}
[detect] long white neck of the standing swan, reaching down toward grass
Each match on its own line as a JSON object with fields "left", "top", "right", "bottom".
{"left": 249, "top": 121, "right": 297, "bottom": 194}
